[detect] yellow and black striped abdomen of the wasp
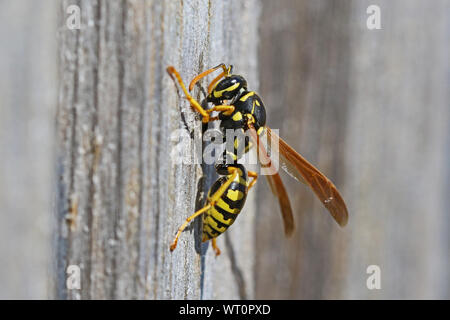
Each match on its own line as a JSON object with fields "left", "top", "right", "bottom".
{"left": 202, "top": 167, "right": 247, "bottom": 241}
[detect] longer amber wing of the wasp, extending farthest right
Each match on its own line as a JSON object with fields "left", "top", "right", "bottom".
{"left": 266, "top": 127, "right": 348, "bottom": 227}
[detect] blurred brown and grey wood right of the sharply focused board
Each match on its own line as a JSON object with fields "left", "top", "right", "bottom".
{"left": 255, "top": 0, "right": 450, "bottom": 299}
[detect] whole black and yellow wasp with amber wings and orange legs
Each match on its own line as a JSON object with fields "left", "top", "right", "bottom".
{"left": 167, "top": 63, "right": 348, "bottom": 255}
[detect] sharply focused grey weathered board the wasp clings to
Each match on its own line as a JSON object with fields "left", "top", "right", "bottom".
{"left": 55, "top": 0, "right": 259, "bottom": 299}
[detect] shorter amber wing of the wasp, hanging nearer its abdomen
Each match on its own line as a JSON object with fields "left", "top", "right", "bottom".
{"left": 248, "top": 127, "right": 295, "bottom": 236}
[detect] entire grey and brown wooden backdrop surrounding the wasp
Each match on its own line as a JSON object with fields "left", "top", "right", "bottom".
{"left": 0, "top": 0, "right": 450, "bottom": 298}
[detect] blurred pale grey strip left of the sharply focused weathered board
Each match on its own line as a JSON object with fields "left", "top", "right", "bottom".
{"left": 0, "top": 1, "right": 57, "bottom": 299}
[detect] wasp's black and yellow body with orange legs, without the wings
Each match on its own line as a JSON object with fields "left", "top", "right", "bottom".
{"left": 167, "top": 63, "right": 266, "bottom": 255}
